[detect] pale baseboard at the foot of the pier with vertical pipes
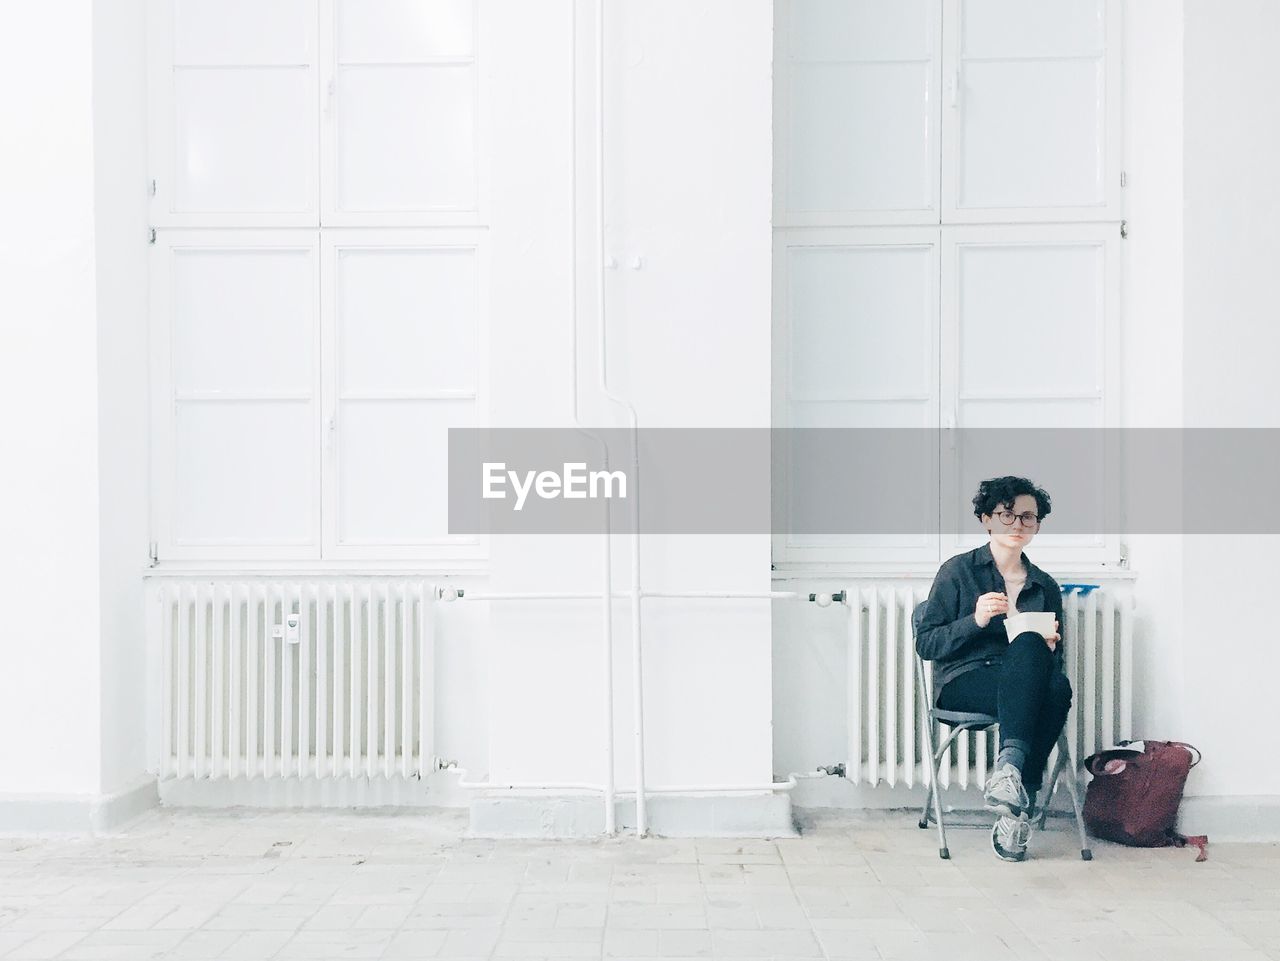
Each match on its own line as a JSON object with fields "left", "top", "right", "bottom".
{"left": 466, "top": 792, "right": 799, "bottom": 838}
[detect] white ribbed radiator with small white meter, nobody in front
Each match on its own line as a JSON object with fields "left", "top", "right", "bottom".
{"left": 151, "top": 577, "right": 434, "bottom": 779}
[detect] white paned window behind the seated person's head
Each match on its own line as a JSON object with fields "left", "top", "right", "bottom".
{"left": 774, "top": 0, "right": 1121, "bottom": 571}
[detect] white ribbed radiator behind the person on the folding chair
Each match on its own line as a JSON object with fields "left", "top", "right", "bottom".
{"left": 845, "top": 585, "right": 1133, "bottom": 787}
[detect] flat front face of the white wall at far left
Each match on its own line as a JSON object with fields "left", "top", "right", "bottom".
{"left": 0, "top": 0, "right": 100, "bottom": 796}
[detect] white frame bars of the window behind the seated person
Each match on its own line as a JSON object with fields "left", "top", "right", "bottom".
{"left": 772, "top": 0, "right": 1126, "bottom": 576}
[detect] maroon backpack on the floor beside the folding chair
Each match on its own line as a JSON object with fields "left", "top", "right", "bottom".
{"left": 1084, "top": 741, "right": 1208, "bottom": 861}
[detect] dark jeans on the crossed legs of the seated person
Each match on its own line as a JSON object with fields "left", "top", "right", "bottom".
{"left": 937, "top": 631, "right": 1071, "bottom": 791}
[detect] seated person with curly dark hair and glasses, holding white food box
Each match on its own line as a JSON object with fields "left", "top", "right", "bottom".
{"left": 915, "top": 477, "right": 1071, "bottom": 861}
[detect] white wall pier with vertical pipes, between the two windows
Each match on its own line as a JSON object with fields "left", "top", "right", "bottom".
{"left": 486, "top": 0, "right": 773, "bottom": 788}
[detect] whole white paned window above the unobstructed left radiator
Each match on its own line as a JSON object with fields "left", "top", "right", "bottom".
{"left": 150, "top": 0, "right": 489, "bottom": 562}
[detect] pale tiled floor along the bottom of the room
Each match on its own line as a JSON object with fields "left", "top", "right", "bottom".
{"left": 0, "top": 811, "right": 1280, "bottom": 961}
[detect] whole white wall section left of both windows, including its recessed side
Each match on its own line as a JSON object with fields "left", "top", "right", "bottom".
{"left": 0, "top": 0, "right": 146, "bottom": 827}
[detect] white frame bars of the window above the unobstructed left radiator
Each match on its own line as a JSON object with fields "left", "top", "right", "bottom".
{"left": 147, "top": 0, "right": 488, "bottom": 573}
